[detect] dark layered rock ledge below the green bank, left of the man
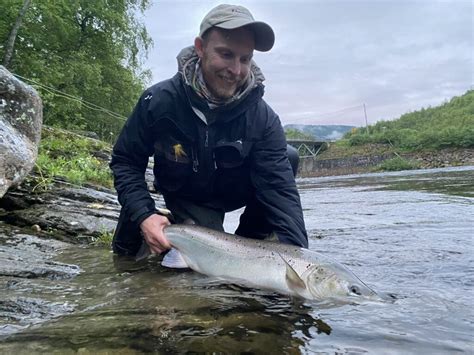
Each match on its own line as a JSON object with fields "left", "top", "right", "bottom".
{"left": 0, "top": 181, "right": 164, "bottom": 243}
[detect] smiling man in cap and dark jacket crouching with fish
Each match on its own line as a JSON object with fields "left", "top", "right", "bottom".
{"left": 110, "top": 5, "right": 308, "bottom": 262}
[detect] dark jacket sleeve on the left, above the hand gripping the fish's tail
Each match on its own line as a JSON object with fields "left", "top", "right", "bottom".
{"left": 110, "top": 92, "right": 155, "bottom": 226}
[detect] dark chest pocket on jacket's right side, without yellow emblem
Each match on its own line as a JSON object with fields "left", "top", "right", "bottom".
{"left": 214, "top": 140, "right": 252, "bottom": 204}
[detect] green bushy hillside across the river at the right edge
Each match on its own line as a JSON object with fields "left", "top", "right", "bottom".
{"left": 344, "top": 90, "right": 474, "bottom": 151}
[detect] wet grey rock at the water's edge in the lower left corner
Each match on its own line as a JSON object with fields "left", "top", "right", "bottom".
{"left": 0, "top": 227, "right": 81, "bottom": 336}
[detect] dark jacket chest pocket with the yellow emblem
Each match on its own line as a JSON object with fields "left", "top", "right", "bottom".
{"left": 153, "top": 136, "right": 193, "bottom": 192}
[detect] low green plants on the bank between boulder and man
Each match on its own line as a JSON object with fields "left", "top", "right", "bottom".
{"left": 35, "top": 128, "right": 113, "bottom": 189}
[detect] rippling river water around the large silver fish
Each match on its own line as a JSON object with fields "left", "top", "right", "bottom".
{"left": 0, "top": 167, "right": 474, "bottom": 354}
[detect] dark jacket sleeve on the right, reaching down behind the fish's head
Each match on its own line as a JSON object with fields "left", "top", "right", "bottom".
{"left": 251, "top": 104, "right": 308, "bottom": 248}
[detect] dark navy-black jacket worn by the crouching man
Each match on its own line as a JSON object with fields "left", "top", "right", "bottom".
{"left": 110, "top": 73, "right": 308, "bottom": 247}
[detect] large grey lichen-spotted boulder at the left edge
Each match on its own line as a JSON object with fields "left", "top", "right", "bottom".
{"left": 0, "top": 65, "right": 43, "bottom": 198}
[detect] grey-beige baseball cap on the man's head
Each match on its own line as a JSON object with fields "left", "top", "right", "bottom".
{"left": 199, "top": 4, "right": 275, "bottom": 52}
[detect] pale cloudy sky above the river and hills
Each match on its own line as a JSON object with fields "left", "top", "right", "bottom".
{"left": 143, "top": 0, "right": 474, "bottom": 126}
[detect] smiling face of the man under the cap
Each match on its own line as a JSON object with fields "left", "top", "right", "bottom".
{"left": 194, "top": 28, "right": 255, "bottom": 99}
